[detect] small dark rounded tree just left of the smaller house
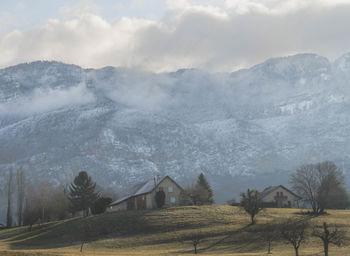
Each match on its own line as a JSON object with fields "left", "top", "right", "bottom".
{"left": 240, "top": 189, "right": 263, "bottom": 225}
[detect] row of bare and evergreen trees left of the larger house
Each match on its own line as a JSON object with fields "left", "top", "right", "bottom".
{"left": 6, "top": 168, "right": 118, "bottom": 229}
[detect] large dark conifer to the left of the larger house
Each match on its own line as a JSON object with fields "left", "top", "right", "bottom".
{"left": 68, "top": 171, "right": 98, "bottom": 217}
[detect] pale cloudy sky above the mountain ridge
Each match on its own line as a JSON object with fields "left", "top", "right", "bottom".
{"left": 0, "top": 0, "right": 350, "bottom": 73}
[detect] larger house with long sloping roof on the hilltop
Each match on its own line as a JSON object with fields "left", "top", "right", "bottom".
{"left": 107, "top": 176, "right": 183, "bottom": 212}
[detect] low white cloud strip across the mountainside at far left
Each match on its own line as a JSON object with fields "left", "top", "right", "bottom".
{"left": 0, "top": 84, "right": 95, "bottom": 116}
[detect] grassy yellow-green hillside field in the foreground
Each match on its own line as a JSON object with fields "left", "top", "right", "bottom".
{"left": 0, "top": 206, "right": 350, "bottom": 256}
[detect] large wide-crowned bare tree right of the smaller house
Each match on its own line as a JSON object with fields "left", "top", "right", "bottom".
{"left": 290, "top": 162, "right": 349, "bottom": 214}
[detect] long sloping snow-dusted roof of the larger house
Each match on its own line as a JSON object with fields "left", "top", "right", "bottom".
{"left": 109, "top": 176, "right": 183, "bottom": 206}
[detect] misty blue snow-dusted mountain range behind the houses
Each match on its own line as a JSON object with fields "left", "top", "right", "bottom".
{"left": 0, "top": 54, "right": 350, "bottom": 222}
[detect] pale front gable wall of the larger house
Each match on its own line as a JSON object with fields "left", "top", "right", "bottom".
{"left": 147, "top": 177, "right": 181, "bottom": 208}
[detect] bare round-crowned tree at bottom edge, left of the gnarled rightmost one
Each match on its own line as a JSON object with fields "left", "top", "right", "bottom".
{"left": 280, "top": 219, "right": 309, "bottom": 256}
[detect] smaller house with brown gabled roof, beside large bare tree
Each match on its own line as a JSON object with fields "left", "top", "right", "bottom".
{"left": 260, "top": 185, "right": 301, "bottom": 208}
